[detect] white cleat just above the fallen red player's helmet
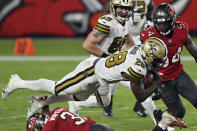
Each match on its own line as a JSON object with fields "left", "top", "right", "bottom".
{"left": 27, "top": 96, "right": 44, "bottom": 119}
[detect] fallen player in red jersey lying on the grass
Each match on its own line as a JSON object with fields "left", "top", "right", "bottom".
{"left": 26, "top": 96, "right": 114, "bottom": 131}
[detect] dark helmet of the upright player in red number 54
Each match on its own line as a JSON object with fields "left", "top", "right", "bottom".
{"left": 153, "top": 3, "right": 176, "bottom": 36}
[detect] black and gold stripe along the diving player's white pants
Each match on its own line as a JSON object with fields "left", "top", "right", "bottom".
{"left": 55, "top": 66, "right": 94, "bottom": 95}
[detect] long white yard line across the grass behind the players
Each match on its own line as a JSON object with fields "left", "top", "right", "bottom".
{"left": 0, "top": 56, "right": 194, "bottom": 62}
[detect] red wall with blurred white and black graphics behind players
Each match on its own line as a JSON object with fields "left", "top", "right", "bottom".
{"left": 0, "top": 0, "right": 197, "bottom": 37}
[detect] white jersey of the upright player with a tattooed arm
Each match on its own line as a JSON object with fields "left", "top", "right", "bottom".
{"left": 94, "top": 14, "right": 132, "bottom": 54}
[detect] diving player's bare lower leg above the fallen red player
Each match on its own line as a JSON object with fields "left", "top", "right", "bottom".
{"left": 44, "top": 95, "right": 74, "bottom": 105}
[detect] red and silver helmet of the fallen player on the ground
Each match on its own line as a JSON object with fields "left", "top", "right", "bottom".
{"left": 26, "top": 113, "right": 46, "bottom": 131}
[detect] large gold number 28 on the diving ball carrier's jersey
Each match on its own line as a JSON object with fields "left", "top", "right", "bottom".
{"left": 105, "top": 51, "right": 127, "bottom": 68}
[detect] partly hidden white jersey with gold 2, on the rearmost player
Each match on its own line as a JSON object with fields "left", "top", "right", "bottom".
{"left": 131, "top": 0, "right": 151, "bottom": 36}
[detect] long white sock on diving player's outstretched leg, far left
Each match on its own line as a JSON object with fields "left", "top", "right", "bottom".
{"left": 15, "top": 79, "right": 55, "bottom": 94}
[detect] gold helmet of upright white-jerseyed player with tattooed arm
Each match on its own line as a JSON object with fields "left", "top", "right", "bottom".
{"left": 110, "top": 0, "right": 133, "bottom": 22}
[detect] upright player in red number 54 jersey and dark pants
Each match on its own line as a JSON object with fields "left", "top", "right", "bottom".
{"left": 140, "top": 3, "right": 197, "bottom": 118}
